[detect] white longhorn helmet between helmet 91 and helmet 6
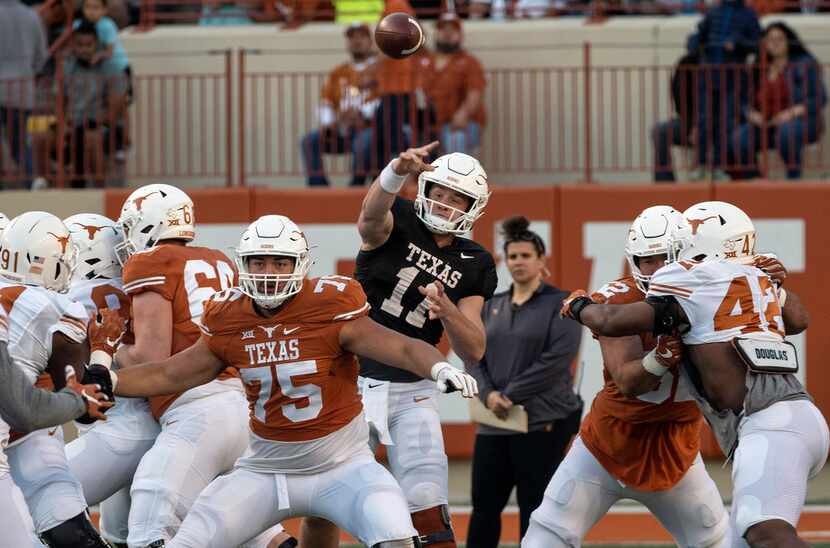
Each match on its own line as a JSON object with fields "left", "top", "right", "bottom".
{"left": 63, "top": 213, "right": 124, "bottom": 283}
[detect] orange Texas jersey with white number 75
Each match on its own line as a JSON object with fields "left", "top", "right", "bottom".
{"left": 203, "top": 276, "right": 369, "bottom": 442}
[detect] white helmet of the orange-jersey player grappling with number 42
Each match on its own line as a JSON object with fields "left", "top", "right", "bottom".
{"left": 625, "top": 206, "right": 685, "bottom": 293}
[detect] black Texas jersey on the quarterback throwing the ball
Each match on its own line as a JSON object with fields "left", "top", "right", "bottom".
{"left": 355, "top": 197, "right": 497, "bottom": 382}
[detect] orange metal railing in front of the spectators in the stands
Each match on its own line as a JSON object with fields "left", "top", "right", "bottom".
{"left": 0, "top": 44, "right": 830, "bottom": 187}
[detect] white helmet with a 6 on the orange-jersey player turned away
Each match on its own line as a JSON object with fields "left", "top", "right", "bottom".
{"left": 116, "top": 184, "right": 196, "bottom": 265}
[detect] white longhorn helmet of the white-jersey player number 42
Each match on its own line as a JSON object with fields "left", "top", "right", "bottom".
{"left": 672, "top": 202, "right": 755, "bottom": 264}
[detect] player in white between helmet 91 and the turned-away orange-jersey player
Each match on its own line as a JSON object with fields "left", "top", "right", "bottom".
{"left": 63, "top": 213, "right": 159, "bottom": 545}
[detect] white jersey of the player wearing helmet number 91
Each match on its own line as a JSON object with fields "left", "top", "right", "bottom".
{"left": 0, "top": 281, "right": 87, "bottom": 442}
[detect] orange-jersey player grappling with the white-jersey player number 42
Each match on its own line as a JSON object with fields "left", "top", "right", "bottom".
{"left": 522, "top": 206, "right": 729, "bottom": 548}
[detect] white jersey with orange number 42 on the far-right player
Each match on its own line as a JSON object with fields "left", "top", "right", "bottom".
{"left": 647, "top": 261, "right": 784, "bottom": 344}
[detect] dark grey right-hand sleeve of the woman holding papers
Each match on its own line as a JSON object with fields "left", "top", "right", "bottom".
{"left": 502, "top": 303, "right": 582, "bottom": 403}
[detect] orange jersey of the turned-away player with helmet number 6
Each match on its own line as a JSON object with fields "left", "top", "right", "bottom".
{"left": 124, "top": 244, "right": 242, "bottom": 419}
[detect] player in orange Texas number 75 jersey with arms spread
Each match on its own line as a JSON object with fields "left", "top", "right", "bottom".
{"left": 107, "top": 215, "right": 477, "bottom": 548}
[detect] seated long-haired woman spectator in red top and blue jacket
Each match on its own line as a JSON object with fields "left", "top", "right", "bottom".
{"left": 732, "top": 22, "right": 827, "bottom": 179}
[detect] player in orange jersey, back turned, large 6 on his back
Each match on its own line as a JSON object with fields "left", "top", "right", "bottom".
{"left": 116, "top": 184, "right": 290, "bottom": 548}
